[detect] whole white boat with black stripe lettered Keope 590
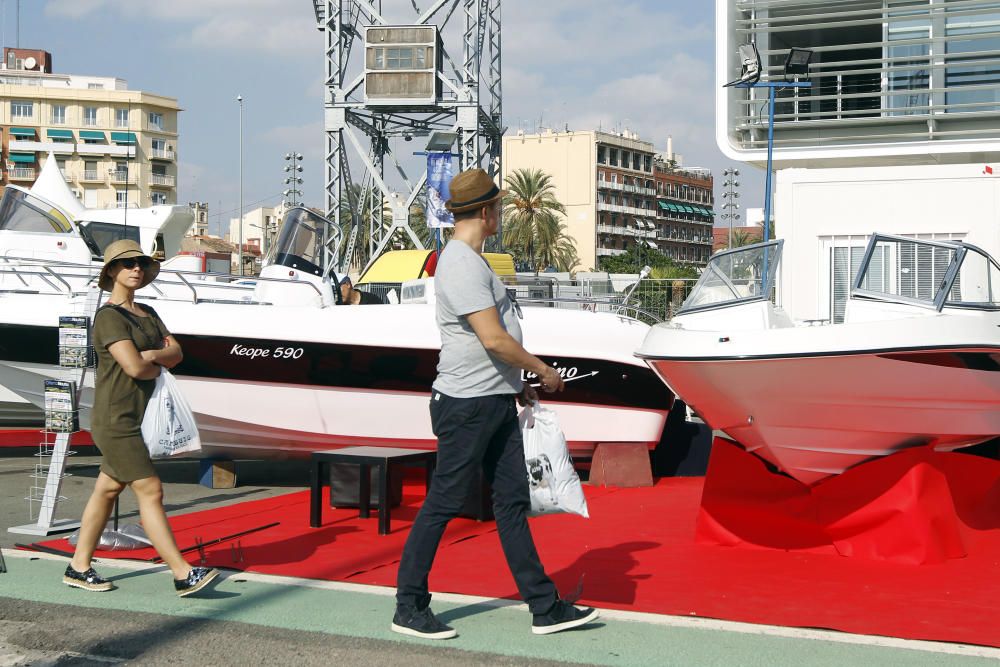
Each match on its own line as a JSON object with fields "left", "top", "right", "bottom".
{"left": 0, "top": 191, "right": 672, "bottom": 457}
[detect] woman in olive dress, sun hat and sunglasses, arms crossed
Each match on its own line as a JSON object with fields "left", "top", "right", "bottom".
{"left": 63, "top": 239, "right": 219, "bottom": 597}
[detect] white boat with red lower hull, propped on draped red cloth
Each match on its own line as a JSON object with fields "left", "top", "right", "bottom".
{"left": 637, "top": 235, "right": 1000, "bottom": 484}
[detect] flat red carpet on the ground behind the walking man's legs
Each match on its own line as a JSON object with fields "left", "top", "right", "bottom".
{"left": 33, "top": 470, "right": 1000, "bottom": 646}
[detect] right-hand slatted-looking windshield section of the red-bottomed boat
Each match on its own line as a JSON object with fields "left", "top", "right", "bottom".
{"left": 851, "top": 235, "right": 1000, "bottom": 310}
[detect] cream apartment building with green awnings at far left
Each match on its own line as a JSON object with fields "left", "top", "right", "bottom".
{"left": 0, "top": 48, "right": 180, "bottom": 208}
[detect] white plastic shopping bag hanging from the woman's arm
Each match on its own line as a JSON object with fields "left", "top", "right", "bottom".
{"left": 142, "top": 368, "right": 201, "bottom": 459}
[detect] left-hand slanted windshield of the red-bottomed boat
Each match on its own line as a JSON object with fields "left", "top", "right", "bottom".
{"left": 677, "top": 241, "right": 783, "bottom": 315}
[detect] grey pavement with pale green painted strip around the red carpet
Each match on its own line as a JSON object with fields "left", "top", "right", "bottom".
{"left": 0, "top": 450, "right": 1000, "bottom": 666}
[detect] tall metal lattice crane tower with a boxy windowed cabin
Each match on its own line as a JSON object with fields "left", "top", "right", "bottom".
{"left": 313, "top": 0, "right": 505, "bottom": 271}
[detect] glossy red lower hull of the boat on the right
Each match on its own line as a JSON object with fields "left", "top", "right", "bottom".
{"left": 647, "top": 346, "right": 1000, "bottom": 484}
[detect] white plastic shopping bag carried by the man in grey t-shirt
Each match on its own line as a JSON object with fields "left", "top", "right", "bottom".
{"left": 520, "top": 403, "right": 590, "bottom": 518}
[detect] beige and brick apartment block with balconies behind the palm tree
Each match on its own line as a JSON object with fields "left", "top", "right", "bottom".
{"left": 503, "top": 130, "right": 713, "bottom": 269}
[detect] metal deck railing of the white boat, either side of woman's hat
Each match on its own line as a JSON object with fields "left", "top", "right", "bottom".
{"left": 0, "top": 256, "right": 323, "bottom": 304}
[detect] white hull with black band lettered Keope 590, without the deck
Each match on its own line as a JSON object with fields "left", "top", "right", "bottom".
{"left": 0, "top": 297, "right": 673, "bottom": 458}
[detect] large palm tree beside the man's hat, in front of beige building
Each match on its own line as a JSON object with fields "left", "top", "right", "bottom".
{"left": 503, "top": 169, "right": 577, "bottom": 275}
